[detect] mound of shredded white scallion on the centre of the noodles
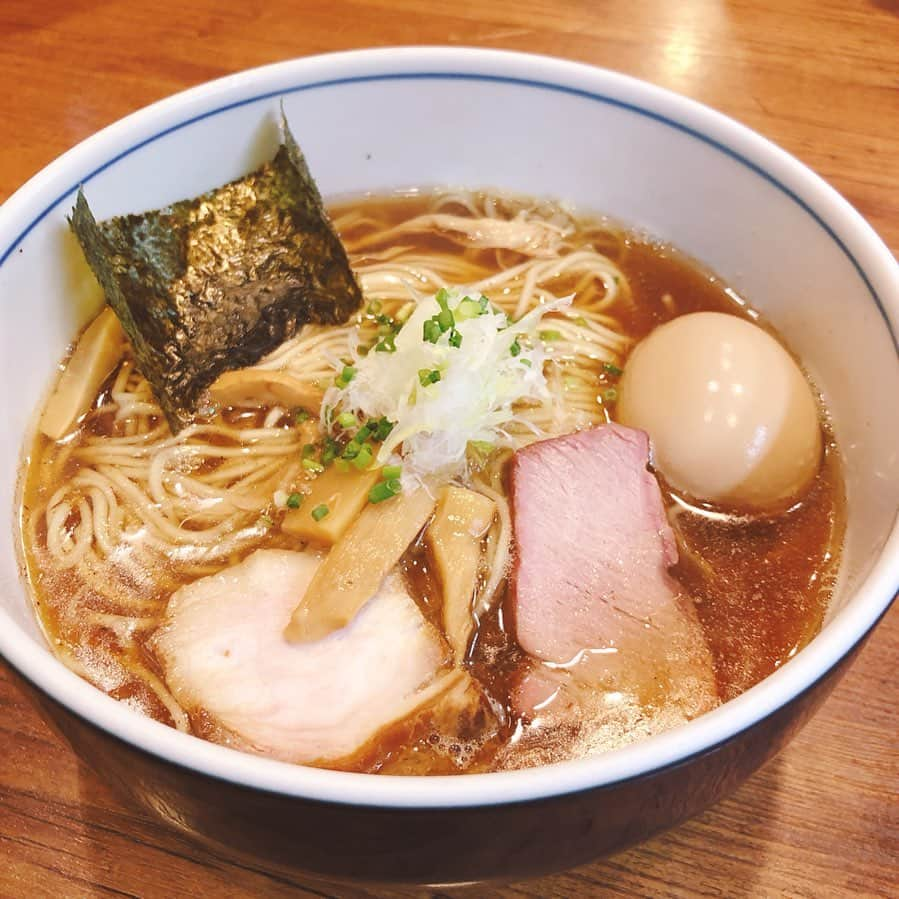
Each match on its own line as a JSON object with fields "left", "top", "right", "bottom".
{"left": 322, "top": 289, "right": 571, "bottom": 487}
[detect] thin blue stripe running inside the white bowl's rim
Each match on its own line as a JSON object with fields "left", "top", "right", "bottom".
{"left": 0, "top": 72, "right": 899, "bottom": 353}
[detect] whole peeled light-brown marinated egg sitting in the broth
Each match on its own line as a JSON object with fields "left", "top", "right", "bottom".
{"left": 618, "top": 312, "right": 821, "bottom": 508}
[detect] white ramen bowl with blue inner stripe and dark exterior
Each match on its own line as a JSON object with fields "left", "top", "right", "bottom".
{"left": 0, "top": 48, "right": 899, "bottom": 883}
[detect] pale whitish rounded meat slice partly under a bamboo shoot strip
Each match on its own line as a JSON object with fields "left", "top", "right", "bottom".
{"left": 151, "top": 550, "right": 458, "bottom": 762}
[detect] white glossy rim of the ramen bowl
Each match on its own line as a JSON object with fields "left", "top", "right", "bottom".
{"left": 0, "top": 47, "right": 899, "bottom": 809}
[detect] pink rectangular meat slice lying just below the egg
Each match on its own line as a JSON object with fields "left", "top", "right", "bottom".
{"left": 510, "top": 424, "right": 718, "bottom": 745}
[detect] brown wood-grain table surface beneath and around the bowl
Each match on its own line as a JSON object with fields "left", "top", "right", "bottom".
{"left": 0, "top": 0, "right": 899, "bottom": 897}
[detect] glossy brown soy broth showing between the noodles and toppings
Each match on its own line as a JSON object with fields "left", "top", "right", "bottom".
{"left": 20, "top": 195, "right": 844, "bottom": 774}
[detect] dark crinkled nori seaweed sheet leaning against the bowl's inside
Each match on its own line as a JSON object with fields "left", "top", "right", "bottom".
{"left": 69, "top": 121, "right": 362, "bottom": 432}
